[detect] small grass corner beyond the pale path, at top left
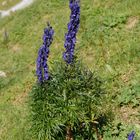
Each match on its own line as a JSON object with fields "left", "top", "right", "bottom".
{"left": 0, "top": 0, "right": 21, "bottom": 10}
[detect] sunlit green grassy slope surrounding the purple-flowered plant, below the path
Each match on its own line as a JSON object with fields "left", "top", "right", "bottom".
{"left": 0, "top": 0, "right": 140, "bottom": 140}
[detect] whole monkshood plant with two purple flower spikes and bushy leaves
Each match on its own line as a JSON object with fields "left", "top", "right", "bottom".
{"left": 30, "top": 0, "right": 111, "bottom": 140}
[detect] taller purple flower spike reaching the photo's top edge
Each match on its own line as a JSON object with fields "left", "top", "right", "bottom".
{"left": 63, "top": 0, "right": 80, "bottom": 64}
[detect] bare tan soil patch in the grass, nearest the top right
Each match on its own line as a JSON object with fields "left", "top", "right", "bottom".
{"left": 126, "top": 17, "right": 139, "bottom": 29}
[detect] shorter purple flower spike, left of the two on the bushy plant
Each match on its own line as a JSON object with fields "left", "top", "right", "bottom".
{"left": 36, "top": 24, "right": 54, "bottom": 83}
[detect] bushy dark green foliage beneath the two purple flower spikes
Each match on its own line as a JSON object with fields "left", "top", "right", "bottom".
{"left": 30, "top": 58, "right": 111, "bottom": 140}
